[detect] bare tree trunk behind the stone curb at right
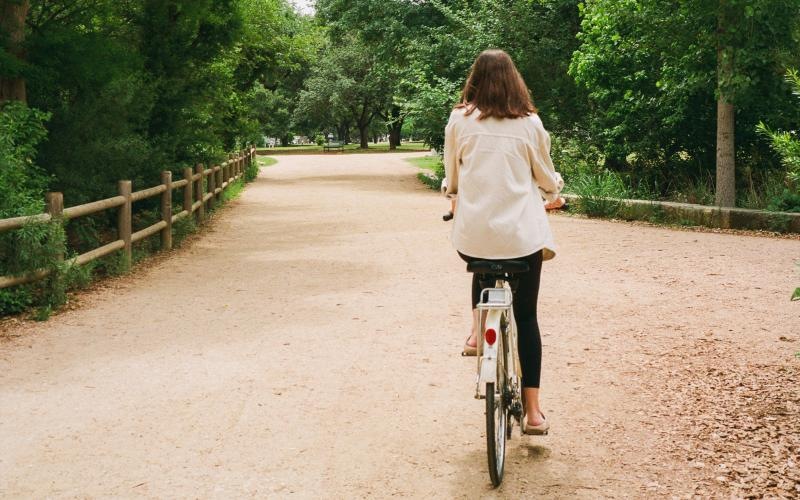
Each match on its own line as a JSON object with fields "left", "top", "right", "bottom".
{"left": 715, "top": 0, "right": 736, "bottom": 207}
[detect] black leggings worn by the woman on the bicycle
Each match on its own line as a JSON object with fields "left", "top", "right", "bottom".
{"left": 458, "top": 250, "right": 542, "bottom": 388}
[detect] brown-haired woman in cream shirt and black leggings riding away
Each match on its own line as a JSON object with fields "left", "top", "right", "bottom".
{"left": 444, "top": 50, "right": 564, "bottom": 434}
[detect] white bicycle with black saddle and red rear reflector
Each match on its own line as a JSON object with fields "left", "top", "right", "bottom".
{"left": 467, "top": 259, "right": 529, "bottom": 486}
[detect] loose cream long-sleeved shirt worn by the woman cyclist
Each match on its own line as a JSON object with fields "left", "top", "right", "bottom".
{"left": 444, "top": 109, "right": 564, "bottom": 260}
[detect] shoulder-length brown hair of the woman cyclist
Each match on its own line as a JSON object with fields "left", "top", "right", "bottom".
{"left": 456, "top": 49, "right": 537, "bottom": 120}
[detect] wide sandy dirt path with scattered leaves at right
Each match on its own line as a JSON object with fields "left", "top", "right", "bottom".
{"left": 0, "top": 155, "right": 800, "bottom": 498}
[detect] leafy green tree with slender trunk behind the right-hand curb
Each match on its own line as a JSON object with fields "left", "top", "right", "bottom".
{"left": 570, "top": 0, "right": 800, "bottom": 205}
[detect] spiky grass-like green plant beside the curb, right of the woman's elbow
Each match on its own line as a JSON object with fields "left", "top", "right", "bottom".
{"left": 572, "top": 170, "right": 628, "bottom": 218}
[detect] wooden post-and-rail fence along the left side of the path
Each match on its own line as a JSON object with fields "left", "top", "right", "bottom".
{"left": 0, "top": 147, "right": 256, "bottom": 289}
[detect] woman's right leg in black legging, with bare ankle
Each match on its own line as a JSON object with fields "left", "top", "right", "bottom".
{"left": 514, "top": 251, "right": 544, "bottom": 425}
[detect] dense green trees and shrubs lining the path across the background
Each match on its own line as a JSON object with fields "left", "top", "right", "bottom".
{"left": 0, "top": 0, "right": 800, "bottom": 313}
